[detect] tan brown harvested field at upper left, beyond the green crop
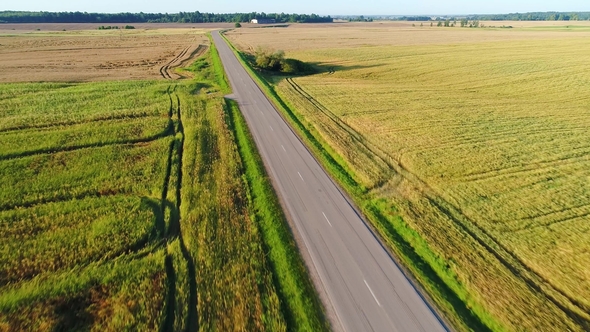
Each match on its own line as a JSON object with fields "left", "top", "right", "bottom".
{"left": 0, "top": 28, "right": 209, "bottom": 83}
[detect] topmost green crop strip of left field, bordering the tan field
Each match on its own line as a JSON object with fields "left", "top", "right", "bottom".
{"left": 0, "top": 81, "right": 170, "bottom": 131}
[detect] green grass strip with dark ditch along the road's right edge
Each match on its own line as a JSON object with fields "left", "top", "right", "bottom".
{"left": 222, "top": 31, "right": 505, "bottom": 331}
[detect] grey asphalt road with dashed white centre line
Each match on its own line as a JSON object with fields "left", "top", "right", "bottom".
{"left": 212, "top": 31, "right": 446, "bottom": 332}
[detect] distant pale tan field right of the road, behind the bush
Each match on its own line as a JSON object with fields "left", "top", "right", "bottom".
{"left": 227, "top": 21, "right": 590, "bottom": 51}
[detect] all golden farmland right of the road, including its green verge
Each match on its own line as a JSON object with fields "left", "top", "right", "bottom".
{"left": 227, "top": 22, "right": 590, "bottom": 330}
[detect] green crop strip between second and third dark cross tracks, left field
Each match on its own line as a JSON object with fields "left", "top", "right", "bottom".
{"left": 0, "top": 138, "right": 170, "bottom": 210}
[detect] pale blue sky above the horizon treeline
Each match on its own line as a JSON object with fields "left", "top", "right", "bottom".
{"left": 0, "top": 0, "right": 590, "bottom": 15}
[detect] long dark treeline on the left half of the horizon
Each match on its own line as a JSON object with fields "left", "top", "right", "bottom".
{"left": 0, "top": 11, "right": 333, "bottom": 23}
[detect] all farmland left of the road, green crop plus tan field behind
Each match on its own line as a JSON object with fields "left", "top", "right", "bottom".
{"left": 0, "top": 30, "right": 327, "bottom": 331}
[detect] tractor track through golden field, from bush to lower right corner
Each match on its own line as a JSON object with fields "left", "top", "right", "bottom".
{"left": 287, "top": 78, "right": 590, "bottom": 329}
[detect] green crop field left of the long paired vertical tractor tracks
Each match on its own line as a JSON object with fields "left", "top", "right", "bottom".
{"left": 0, "top": 82, "right": 173, "bottom": 331}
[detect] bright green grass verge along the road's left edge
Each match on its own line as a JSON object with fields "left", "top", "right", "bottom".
{"left": 226, "top": 100, "right": 329, "bottom": 331}
